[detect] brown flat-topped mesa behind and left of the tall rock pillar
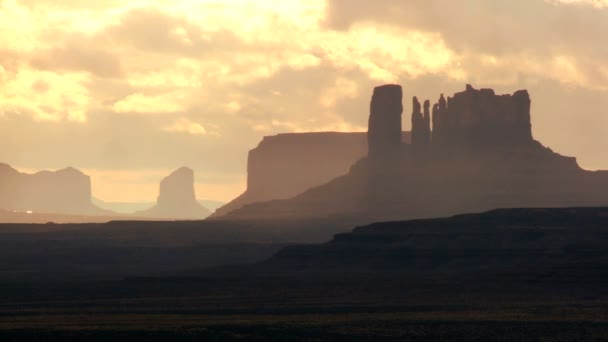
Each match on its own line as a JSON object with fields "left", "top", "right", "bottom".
{"left": 213, "top": 131, "right": 409, "bottom": 217}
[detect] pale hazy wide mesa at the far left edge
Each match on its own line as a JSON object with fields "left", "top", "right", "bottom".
{"left": 0, "top": 163, "right": 103, "bottom": 215}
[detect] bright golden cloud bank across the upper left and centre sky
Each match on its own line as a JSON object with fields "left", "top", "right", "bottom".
{"left": 0, "top": 0, "right": 458, "bottom": 121}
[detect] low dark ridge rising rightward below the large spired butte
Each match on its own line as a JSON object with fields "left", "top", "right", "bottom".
{"left": 261, "top": 208, "right": 608, "bottom": 276}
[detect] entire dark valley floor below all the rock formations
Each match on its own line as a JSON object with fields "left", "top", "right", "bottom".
{"left": 0, "top": 208, "right": 608, "bottom": 341}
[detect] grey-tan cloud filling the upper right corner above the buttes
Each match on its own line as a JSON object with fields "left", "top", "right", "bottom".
{"left": 326, "top": 0, "right": 608, "bottom": 89}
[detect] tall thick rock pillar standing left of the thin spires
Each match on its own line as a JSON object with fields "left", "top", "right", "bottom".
{"left": 367, "top": 84, "right": 403, "bottom": 160}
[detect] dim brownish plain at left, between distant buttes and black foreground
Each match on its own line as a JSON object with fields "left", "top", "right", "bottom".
{"left": 0, "top": 220, "right": 353, "bottom": 283}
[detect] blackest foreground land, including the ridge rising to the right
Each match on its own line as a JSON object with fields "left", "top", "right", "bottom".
{"left": 0, "top": 208, "right": 608, "bottom": 341}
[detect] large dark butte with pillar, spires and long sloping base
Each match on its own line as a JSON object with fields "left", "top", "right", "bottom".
{"left": 228, "top": 85, "right": 608, "bottom": 223}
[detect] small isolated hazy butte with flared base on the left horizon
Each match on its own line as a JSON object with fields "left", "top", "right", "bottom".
{"left": 136, "top": 167, "right": 211, "bottom": 220}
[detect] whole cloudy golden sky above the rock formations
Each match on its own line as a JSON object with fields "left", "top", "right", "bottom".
{"left": 0, "top": 0, "right": 608, "bottom": 202}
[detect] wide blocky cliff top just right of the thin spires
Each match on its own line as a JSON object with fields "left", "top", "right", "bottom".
{"left": 433, "top": 85, "right": 532, "bottom": 146}
